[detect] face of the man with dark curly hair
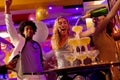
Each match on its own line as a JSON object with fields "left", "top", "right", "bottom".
{"left": 23, "top": 25, "right": 34, "bottom": 39}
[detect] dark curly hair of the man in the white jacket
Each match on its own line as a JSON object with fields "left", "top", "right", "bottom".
{"left": 18, "top": 20, "right": 37, "bottom": 36}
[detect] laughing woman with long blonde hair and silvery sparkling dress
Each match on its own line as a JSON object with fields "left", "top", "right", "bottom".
{"left": 51, "top": 17, "right": 70, "bottom": 68}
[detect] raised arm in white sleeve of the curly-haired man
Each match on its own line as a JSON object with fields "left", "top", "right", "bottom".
{"left": 5, "top": 0, "right": 19, "bottom": 46}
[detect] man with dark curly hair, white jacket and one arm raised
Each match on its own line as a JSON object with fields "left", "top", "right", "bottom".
{"left": 5, "top": 0, "right": 46, "bottom": 80}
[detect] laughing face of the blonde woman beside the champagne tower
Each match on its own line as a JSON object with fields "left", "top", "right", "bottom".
{"left": 58, "top": 18, "right": 69, "bottom": 35}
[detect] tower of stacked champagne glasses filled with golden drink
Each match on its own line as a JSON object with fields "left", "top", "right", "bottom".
{"left": 68, "top": 26, "right": 99, "bottom": 66}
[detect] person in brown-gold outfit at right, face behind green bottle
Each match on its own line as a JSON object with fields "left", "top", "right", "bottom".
{"left": 86, "top": 0, "right": 120, "bottom": 80}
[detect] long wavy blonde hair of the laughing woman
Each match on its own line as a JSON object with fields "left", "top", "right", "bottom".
{"left": 51, "top": 16, "right": 69, "bottom": 50}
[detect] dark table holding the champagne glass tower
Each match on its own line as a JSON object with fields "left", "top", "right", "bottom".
{"left": 41, "top": 62, "right": 120, "bottom": 80}
